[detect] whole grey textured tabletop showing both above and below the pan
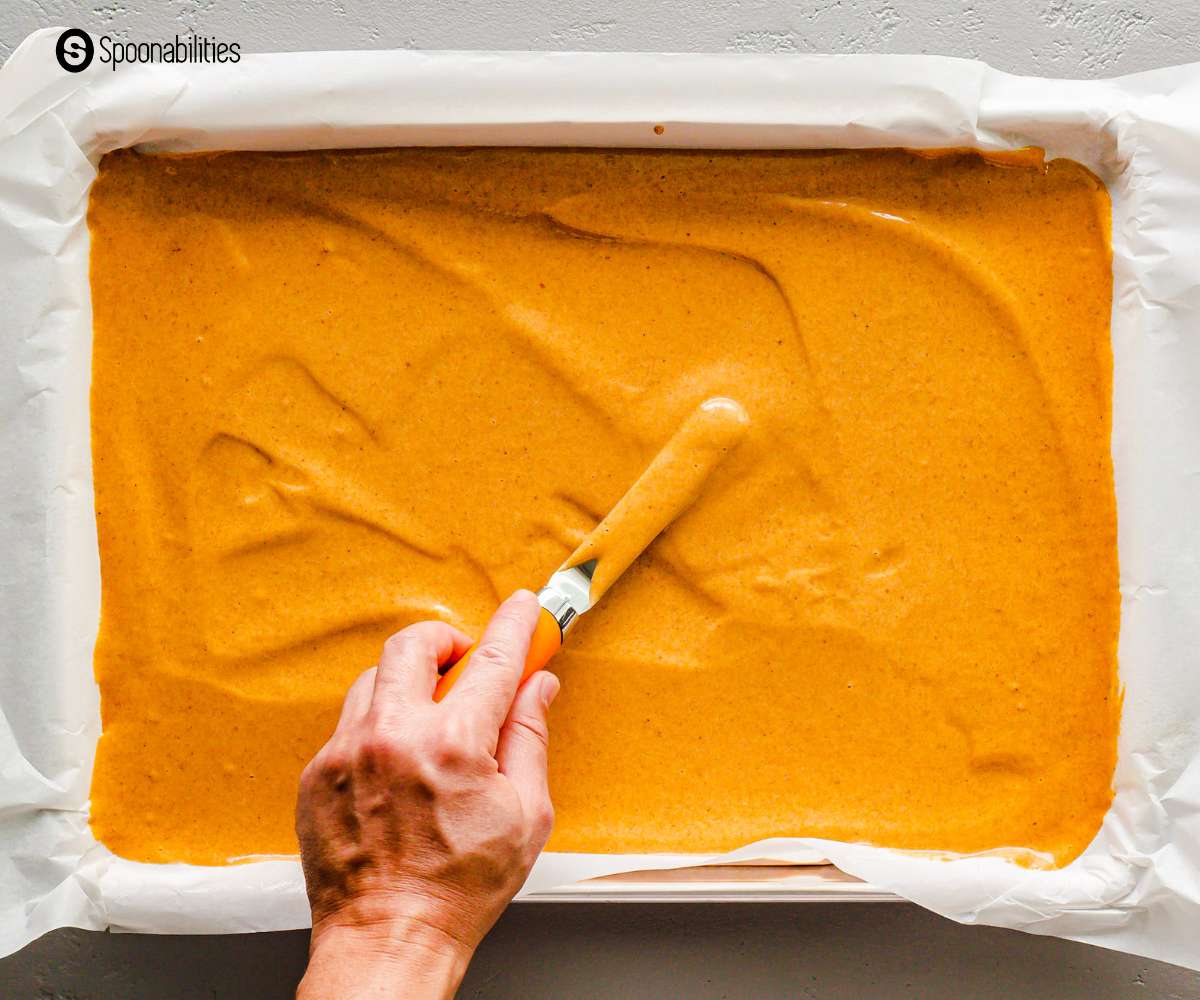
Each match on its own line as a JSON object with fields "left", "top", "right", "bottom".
{"left": 0, "top": 0, "right": 1200, "bottom": 1000}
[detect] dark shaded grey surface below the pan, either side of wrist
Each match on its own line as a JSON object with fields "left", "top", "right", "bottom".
{"left": 7, "top": 903, "right": 1200, "bottom": 1000}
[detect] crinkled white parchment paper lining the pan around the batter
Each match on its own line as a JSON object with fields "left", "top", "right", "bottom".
{"left": 0, "top": 29, "right": 1200, "bottom": 968}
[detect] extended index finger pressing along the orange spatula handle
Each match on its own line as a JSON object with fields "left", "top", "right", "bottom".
{"left": 443, "top": 591, "right": 541, "bottom": 741}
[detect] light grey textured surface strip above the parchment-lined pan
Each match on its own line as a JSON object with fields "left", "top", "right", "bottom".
{"left": 0, "top": 0, "right": 1200, "bottom": 77}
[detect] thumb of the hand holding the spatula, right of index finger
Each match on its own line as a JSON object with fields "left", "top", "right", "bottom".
{"left": 496, "top": 670, "right": 558, "bottom": 849}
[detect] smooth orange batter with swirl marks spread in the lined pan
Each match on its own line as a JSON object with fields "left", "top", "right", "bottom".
{"left": 90, "top": 150, "right": 1120, "bottom": 863}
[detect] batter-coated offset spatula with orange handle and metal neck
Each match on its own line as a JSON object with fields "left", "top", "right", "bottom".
{"left": 433, "top": 396, "right": 750, "bottom": 701}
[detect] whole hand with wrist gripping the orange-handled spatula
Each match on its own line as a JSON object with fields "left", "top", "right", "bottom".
{"left": 296, "top": 591, "right": 558, "bottom": 1000}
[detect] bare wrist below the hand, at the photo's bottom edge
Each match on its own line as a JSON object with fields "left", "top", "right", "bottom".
{"left": 296, "top": 914, "right": 474, "bottom": 1000}
